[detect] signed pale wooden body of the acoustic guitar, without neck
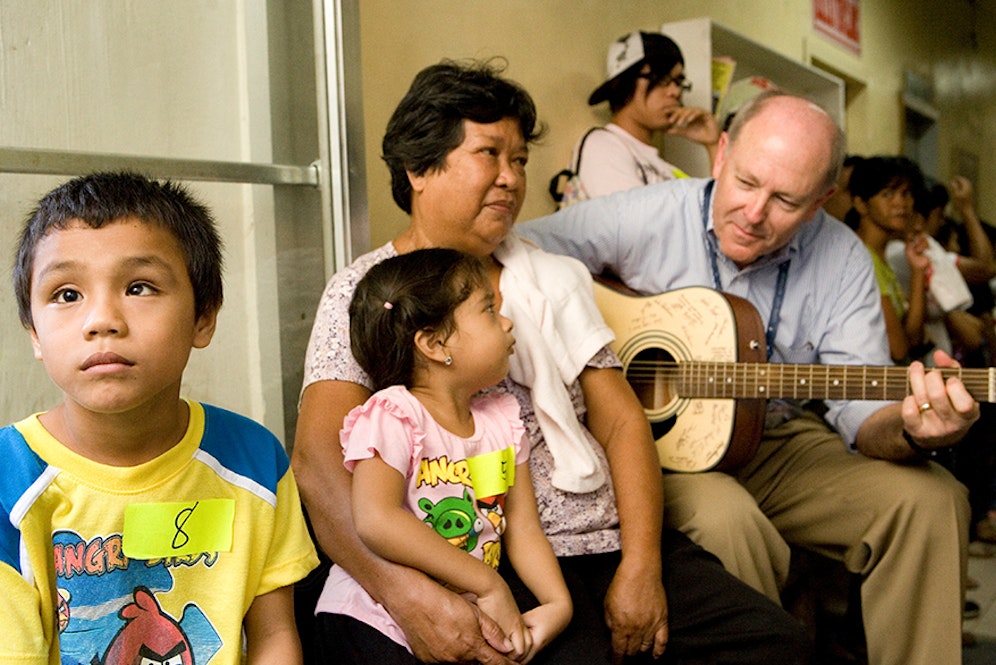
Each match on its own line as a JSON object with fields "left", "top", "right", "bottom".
{"left": 595, "top": 281, "right": 767, "bottom": 473}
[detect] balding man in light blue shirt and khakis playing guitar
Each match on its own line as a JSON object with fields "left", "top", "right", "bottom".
{"left": 517, "top": 92, "right": 979, "bottom": 665}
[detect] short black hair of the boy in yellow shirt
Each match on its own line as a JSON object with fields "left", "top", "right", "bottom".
{"left": 14, "top": 172, "right": 224, "bottom": 328}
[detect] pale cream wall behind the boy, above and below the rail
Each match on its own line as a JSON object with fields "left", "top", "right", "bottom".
{"left": 0, "top": 0, "right": 292, "bottom": 435}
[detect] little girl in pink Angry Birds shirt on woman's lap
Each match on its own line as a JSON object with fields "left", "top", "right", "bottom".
{"left": 317, "top": 249, "right": 571, "bottom": 664}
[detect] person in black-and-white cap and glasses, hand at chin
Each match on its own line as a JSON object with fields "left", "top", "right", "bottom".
{"left": 556, "top": 31, "right": 720, "bottom": 205}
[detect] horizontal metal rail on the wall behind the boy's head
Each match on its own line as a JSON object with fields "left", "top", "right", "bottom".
{"left": 0, "top": 147, "right": 321, "bottom": 187}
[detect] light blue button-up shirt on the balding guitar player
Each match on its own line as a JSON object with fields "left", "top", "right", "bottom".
{"left": 515, "top": 178, "right": 892, "bottom": 450}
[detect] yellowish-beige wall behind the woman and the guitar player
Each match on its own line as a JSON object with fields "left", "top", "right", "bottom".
{"left": 360, "top": 0, "right": 996, "bottom": 246}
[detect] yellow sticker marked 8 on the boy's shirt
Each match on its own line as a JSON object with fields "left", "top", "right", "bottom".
{"left": 122, "top": 499, "right": 235, "bottom": 559}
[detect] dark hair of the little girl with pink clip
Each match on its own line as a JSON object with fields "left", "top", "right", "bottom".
{"left": 349, "top": 248, "right": 488, "bottom": 390}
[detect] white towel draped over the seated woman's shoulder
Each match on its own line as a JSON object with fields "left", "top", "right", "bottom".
{"left": 495, "top": 233, "right": 614, "bottom": 493}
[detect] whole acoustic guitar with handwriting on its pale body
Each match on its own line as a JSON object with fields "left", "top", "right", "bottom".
{"left": 595, "top": 281, "right": 996, "bottom": 473}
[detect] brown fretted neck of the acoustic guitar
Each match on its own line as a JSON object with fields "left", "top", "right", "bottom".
{"left": 658, "top": 361, "right": 996, "bottom": 402}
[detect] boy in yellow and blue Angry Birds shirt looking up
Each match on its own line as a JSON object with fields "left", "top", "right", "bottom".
{"left": 0, "top": 173, "right": 318, "bottom": 665}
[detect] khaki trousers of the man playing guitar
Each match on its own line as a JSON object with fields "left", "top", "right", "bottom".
{"left": 664, "top": 417, "right": 970, "bottom": 665}
